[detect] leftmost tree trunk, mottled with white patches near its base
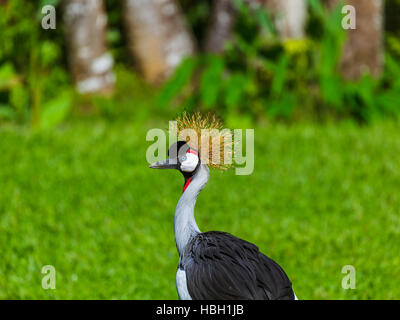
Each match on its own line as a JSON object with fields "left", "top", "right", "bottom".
{"left": 63, "top": 0, "right": 115, "bottom": 93}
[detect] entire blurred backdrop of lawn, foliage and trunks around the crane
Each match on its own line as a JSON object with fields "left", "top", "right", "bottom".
{"left": 0, "top": 0, "right": 400, "bottom": 299}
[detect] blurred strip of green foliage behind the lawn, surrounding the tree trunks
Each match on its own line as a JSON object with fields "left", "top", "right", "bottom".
{"left": 0, "top": 0, "right": 400, "bottom": 128}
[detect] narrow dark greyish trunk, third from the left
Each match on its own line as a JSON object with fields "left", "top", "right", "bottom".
{"left": 204, "top": 0, "right": 237, "bottom": 53}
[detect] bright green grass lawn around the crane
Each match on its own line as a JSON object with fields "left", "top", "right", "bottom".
{"left": 0, "top": 120, "right": 400, "bottom": 299}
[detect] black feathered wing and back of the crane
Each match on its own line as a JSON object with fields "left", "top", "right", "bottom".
{"left": 181, "top": 231, "right": 294, "bottom": 300}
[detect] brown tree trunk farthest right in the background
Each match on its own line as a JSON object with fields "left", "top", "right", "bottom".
{"left": 341, "top": 0, "right": 383, "bottom": 80}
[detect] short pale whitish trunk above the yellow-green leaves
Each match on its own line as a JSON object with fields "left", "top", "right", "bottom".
{"left": 266, "top": 0, "right": 307, "bottom": 39}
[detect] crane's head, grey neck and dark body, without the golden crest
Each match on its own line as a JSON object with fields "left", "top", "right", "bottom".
{"left": 150, "top": 112, "right": 297, "bottom": 300}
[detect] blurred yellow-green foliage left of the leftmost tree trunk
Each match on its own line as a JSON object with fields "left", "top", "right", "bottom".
{"left": 0, "top": 0, "right": 72, "bottom": 128}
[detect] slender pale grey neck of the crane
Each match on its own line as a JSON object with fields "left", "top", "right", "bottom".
{"left": 174, "top": 164, "right": 210, "bottom": 256}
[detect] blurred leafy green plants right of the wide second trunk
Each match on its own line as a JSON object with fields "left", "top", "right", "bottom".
{"left": 158, "top": 0, "right": 400, "bottom": 122}
